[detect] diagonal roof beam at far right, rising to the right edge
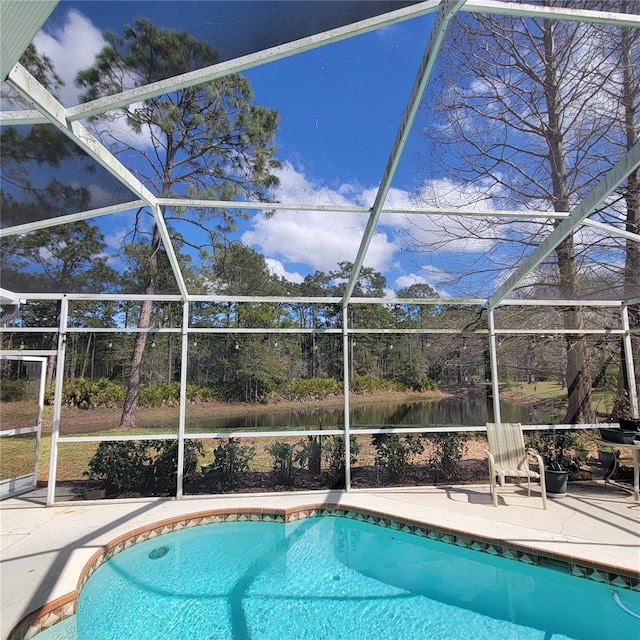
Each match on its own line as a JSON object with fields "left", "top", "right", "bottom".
{"left": 488, "top": 141, "right": 640, "bottom": 309}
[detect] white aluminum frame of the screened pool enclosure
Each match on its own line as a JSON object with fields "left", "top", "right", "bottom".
{"left": 0, "top": 0, "right": 640, "bottom": 504}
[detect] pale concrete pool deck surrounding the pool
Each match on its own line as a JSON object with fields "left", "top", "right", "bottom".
{"left": 0, "top": 482, "right": 640, "bottom": 639}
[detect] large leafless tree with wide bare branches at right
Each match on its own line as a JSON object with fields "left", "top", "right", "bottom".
{"left": 412, "top": 1, "right": 636, "bottom": 423}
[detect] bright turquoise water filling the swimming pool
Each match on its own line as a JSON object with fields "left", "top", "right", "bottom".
{"left": 38, "top": 517, "right": 640, "bottom": 640}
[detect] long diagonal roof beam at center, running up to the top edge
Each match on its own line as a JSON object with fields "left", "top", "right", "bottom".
{"left": 342, "top": 0, "right": 465, "bottom": 308}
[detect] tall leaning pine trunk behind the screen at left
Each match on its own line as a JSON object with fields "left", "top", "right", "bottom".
{"left": 120, "top": 226, "right": 161, "bottom": 429}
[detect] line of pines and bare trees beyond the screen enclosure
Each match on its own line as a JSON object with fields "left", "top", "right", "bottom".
{"left": 0, "top": 7, "right": 640, "bottom": 427}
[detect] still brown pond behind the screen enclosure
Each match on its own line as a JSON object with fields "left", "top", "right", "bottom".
{"left": 187, "top": 396, "right": 558, "bottom": 433}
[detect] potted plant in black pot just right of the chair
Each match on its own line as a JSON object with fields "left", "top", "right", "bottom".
{"left": 529, "top": 429, "right": 580, "bottom": 498}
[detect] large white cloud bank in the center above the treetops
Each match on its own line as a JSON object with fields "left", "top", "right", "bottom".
{"left": 242, "top": 162, "right": 516, "bottom": 288}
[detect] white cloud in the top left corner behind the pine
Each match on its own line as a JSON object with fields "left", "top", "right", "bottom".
{"left": 34, "top": 9, "right": 106, "bottom": 106}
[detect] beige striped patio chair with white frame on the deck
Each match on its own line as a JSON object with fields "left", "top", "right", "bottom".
{"left": 486, "top": 422, "right": 547, "bottom": 509}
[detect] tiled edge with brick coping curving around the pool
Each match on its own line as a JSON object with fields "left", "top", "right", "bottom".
{"left": 7, "top": 503, "right": 640, "bottom": 640}
